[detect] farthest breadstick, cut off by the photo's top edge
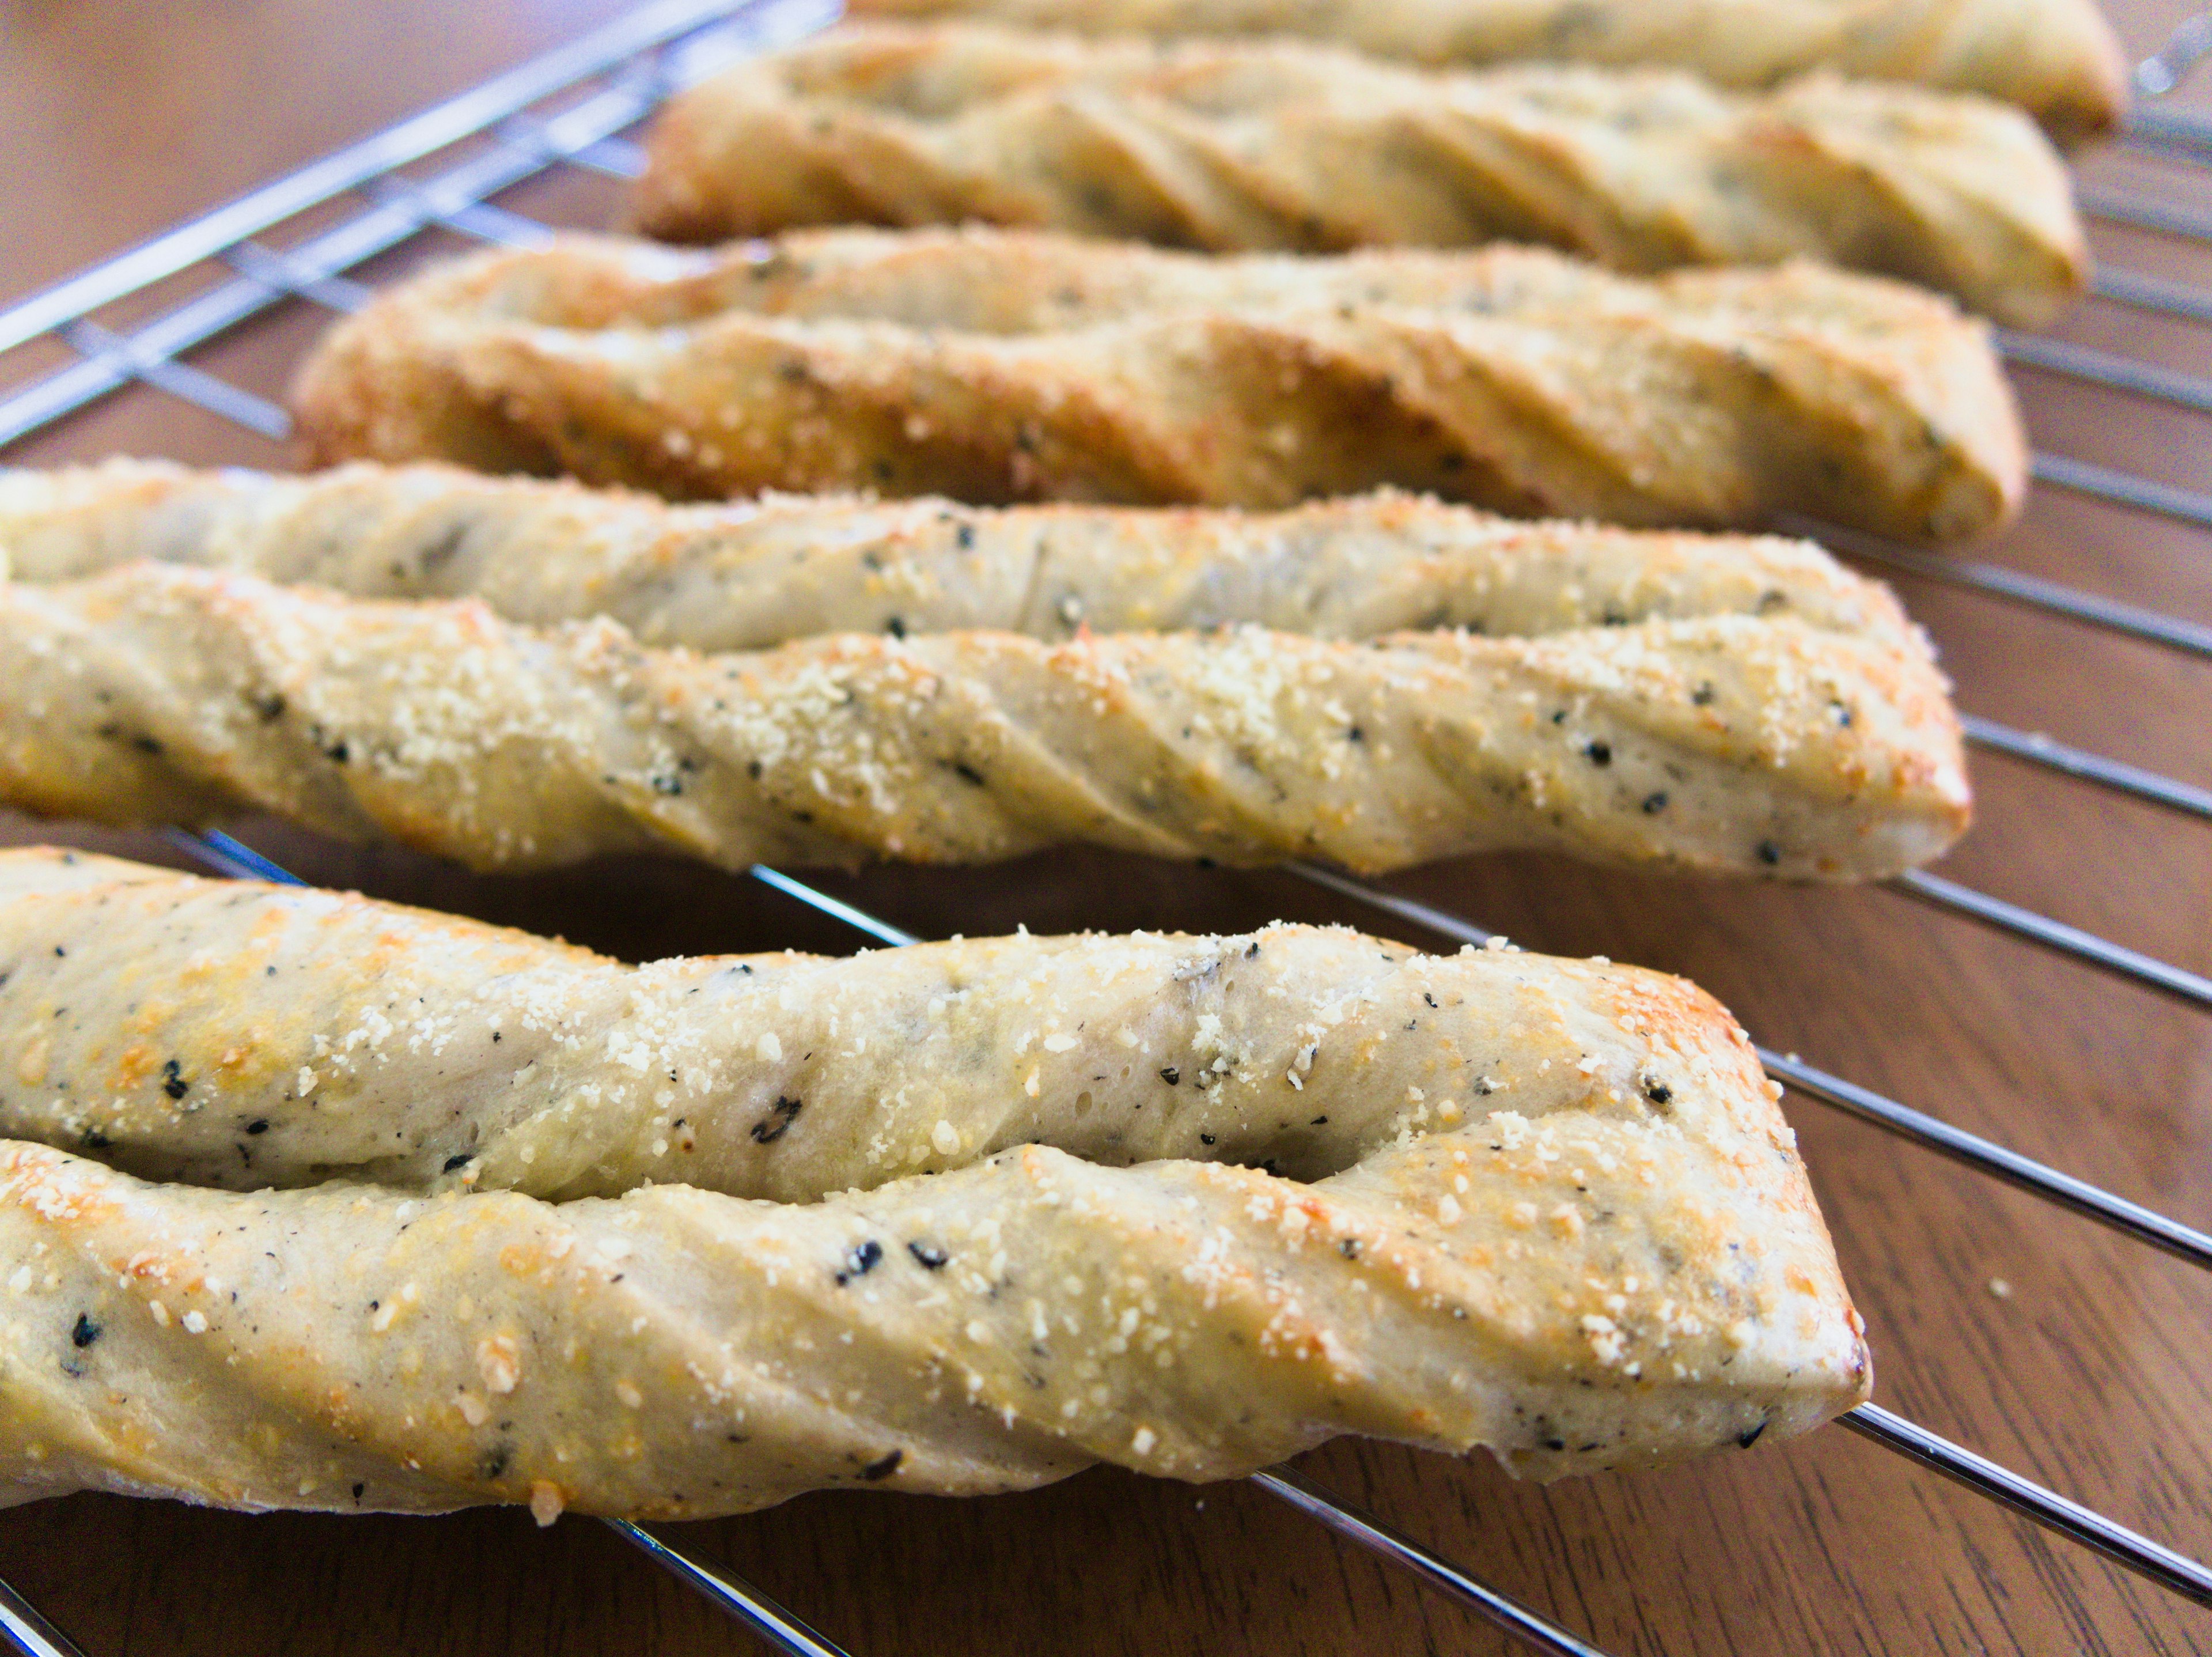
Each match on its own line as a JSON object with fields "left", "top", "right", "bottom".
{"left": 851, "top": 0, "right": 2128, "bottom": 137}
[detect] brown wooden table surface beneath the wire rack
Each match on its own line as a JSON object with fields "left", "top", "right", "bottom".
{"left": 0, "top": 0, "right": 2212, "bottom": 1657}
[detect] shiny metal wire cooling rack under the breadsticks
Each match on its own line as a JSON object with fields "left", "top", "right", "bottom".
{"left": 0, "top": 0, "right": 2212, "bottom": 1657}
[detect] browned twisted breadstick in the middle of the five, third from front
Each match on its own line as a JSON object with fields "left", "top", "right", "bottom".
{"left": 297, "top": 232, "right": 2026, "bottom": 540}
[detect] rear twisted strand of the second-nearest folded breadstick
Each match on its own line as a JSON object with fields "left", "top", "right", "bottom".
{"left": 0, "top": 460, "right": 1911, "bottom": 650}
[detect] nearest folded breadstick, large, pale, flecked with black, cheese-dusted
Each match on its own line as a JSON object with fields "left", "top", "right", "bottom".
{"left": 0, "top": 854, "right": 1869, "bottom": 1520}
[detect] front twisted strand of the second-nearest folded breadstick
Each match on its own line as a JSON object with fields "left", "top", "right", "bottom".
{"left": 0, "top": 564, "right": 1967, "bottom": 880}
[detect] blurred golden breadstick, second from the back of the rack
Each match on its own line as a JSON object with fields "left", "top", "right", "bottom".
{"left": 637, "top": 24, "right": 2088, "bottom": 325}
